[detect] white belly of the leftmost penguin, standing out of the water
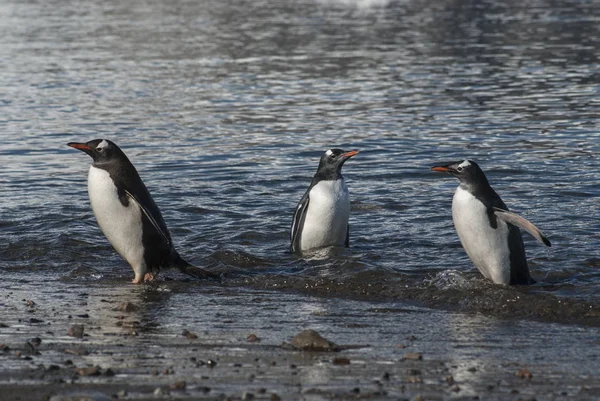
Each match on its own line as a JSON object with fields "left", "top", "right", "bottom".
{"left": 88, "top": 166, "right": 145, "bottom": 270}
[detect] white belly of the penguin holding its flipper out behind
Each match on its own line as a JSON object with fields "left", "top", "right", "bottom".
{"left": 452, "top": 187, "right": 510, "bottom": 285}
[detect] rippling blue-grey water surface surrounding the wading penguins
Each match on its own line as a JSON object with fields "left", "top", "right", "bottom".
{"left": 0, "top": 0, "right": 600, "bottom": 325}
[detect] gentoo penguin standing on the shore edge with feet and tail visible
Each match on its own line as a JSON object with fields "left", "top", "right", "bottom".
{"left": 67, "top": 139, "right": 216, "bottom": 284}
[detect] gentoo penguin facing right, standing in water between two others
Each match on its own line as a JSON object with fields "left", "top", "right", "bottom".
{"left": 291, "top": 149, "right": 358, "bottom": 252}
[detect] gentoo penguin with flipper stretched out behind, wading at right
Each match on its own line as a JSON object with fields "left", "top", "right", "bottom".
{"left": 431, "top": 160, "right": 550, "bottom": 285}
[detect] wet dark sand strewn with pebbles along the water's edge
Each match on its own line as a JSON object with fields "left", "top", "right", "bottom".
{"left": 0, "top": 281, "right": 600, "bottom": 401}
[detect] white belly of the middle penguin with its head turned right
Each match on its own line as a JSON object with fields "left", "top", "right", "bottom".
{"left": 300, "top": 180, "right": 350, "bottom": 250}
